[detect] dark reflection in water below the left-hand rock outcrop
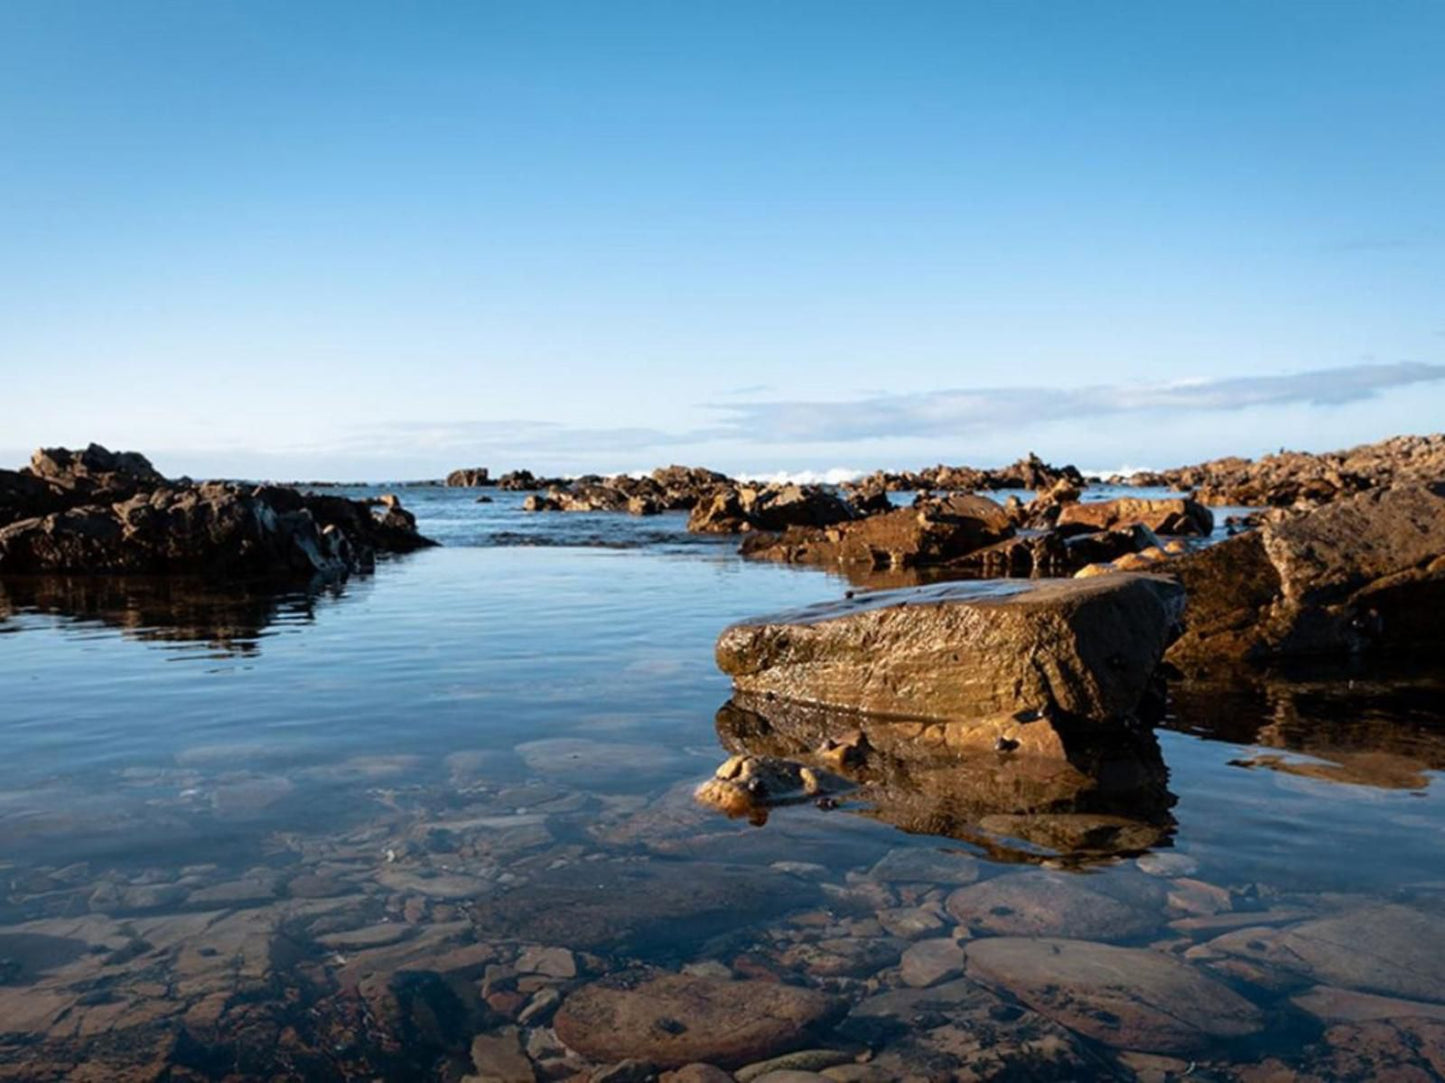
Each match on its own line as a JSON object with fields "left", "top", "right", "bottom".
{"left": 0, "top": 575, "right": 342, "bottom": 654}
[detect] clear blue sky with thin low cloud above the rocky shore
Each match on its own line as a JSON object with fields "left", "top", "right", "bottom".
{"left": 0, "top": 0, "right": 1445, "bottom": 479}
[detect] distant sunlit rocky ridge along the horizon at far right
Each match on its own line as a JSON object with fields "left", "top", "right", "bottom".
{"left": 1123, "top": 434, "right": 1445, "bottom": 508}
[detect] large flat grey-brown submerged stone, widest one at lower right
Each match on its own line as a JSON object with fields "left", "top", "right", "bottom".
{"left": 967, "top": 937, "right": 1264, "bottom": 1053}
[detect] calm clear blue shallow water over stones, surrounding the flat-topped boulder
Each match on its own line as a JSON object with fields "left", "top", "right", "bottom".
{"left": 0, "top": 489, "right": 1445, "bottom": 1079}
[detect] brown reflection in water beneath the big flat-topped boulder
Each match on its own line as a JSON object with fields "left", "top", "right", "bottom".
{"left": 717, "top": 695, "right": 1176, "bottom": 863}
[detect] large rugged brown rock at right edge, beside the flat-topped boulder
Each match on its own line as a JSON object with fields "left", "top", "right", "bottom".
{"left": 1166, "top": 483, "right": 1445, "bottom": 665}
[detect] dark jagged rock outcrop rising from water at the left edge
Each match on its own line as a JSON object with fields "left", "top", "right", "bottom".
{"left": 0, "top": 444, "right": 434, "bottom": 578}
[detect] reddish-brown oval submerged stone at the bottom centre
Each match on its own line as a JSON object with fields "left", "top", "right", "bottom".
{"left": 553, "top": 975, "right": 842, "bottom": 1069}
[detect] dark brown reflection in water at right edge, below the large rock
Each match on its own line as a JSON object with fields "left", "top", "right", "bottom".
{"left": 1163, "top": 659, "right": 1445, "bottom": 789}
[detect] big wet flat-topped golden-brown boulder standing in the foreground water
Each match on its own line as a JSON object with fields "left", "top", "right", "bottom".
{"left": 717, "top": 575, "right": 1183, "bottom": 722}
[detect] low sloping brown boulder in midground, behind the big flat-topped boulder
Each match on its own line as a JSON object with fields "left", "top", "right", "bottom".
{"left": 743, "top": 495, "right": 1013, "bottom": 568}
